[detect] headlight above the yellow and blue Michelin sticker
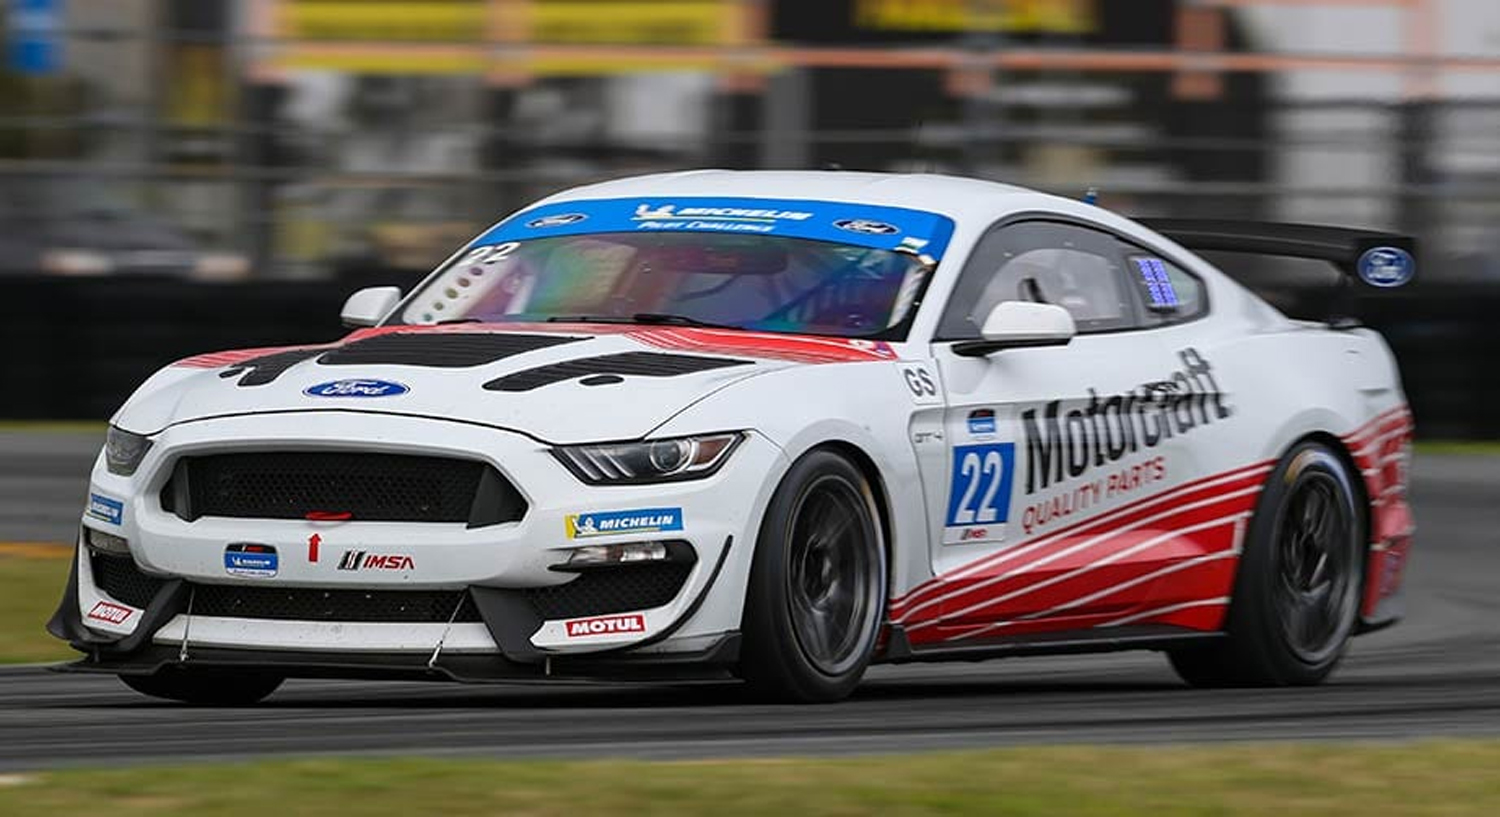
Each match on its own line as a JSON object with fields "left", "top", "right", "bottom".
{"left": 552, "top": 433, "right": 744, "bottom": 486}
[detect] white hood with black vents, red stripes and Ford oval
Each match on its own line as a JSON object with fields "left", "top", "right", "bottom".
{"left": 116, "top": 324, "right": 896, "bottom": 442}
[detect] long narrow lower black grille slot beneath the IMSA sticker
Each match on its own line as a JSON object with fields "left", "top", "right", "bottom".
{"left": 192, "top": 585, "right": 480, "bottom": 624}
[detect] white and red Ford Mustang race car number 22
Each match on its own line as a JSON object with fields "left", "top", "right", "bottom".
{"left": 50, "top": 171, "right": 1415, "bottom": 703}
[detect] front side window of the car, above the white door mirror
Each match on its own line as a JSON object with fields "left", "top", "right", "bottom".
{"left": 938, "top": 222, "right": 1140, "bottom": 340}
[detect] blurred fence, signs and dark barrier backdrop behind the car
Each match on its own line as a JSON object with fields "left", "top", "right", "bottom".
{"left": 0, "top": 0, "right": 1500, "bottom": 438}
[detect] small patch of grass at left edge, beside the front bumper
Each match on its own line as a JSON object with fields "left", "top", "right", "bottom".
{"left": 0, "top": 547, "right": 78, "bottom": 662}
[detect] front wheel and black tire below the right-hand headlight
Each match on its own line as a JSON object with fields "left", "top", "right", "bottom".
{"left": 740, "top": 450, "right": 888, "bottom": 703}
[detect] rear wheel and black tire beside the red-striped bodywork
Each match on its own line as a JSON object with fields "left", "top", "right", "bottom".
{"left": 1169, "top": 442, "right": 1365, "bottom": 687}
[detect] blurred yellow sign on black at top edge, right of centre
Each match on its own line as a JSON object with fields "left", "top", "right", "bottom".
{"left": 854, "top": 0, "right": 1098, "bottom": 34}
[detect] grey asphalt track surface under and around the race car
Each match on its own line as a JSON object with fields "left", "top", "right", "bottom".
{"left": 0, "top": 433, "right": 1500, "bottom": 771}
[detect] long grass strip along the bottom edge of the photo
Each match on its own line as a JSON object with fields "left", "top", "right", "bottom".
{"left": 0, "top": 741, "right": 1500, "bottom": 817}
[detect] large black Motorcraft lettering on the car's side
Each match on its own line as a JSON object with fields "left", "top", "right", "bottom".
{"left": 1022, "top": 348, "right": 1233, "bottom": 493}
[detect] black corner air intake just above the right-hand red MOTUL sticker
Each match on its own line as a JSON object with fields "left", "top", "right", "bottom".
{"left": 524, "top": 562, "right": 693, "bottom": 619}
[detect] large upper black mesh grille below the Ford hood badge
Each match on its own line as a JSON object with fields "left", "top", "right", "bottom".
{"left": 162, "top": 451, "right": 527, "bottom": 528}
